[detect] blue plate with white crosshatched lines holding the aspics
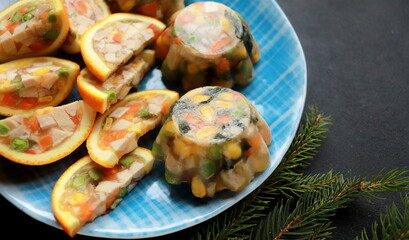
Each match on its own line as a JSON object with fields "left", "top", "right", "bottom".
{"left": 0, "top": 0, "right": 307, "bottom": 238}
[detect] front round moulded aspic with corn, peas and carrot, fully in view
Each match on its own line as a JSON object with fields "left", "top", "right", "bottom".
{"left": 152, "top": 86, "right": 272, "bottom": 197}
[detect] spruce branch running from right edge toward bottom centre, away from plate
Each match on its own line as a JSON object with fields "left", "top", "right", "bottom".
{"left": 251, "top": 169, "right": 409, "bottom": 239}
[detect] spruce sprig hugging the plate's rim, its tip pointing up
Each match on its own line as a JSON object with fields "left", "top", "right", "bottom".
{"left": 193, "top": 107, "right": 330, "bottom": 240}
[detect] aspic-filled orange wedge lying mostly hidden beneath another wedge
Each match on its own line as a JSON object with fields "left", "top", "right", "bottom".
{"left": 77, "top": 49, "right": 155, "bottom": 113}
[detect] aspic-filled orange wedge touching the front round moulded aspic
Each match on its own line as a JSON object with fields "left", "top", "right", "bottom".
{"left": 87, "top": 89, "right": 179, "bottom": 168}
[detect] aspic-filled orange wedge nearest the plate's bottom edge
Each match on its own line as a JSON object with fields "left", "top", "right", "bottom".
{"left": 51, "top": 147, "right": 155, "bottom": 237}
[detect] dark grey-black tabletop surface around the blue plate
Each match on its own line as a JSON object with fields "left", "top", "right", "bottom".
{"left": 0, "top": 0, "right": 409, "bottom": 240}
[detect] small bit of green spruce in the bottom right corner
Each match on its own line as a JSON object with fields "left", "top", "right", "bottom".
{"left": 355, "top": 193, "right": 409, "bottom": 240}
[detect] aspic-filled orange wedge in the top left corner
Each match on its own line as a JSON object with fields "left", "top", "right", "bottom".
{"left": 0, "top": 0, "right": 69, "bottom": 63}
